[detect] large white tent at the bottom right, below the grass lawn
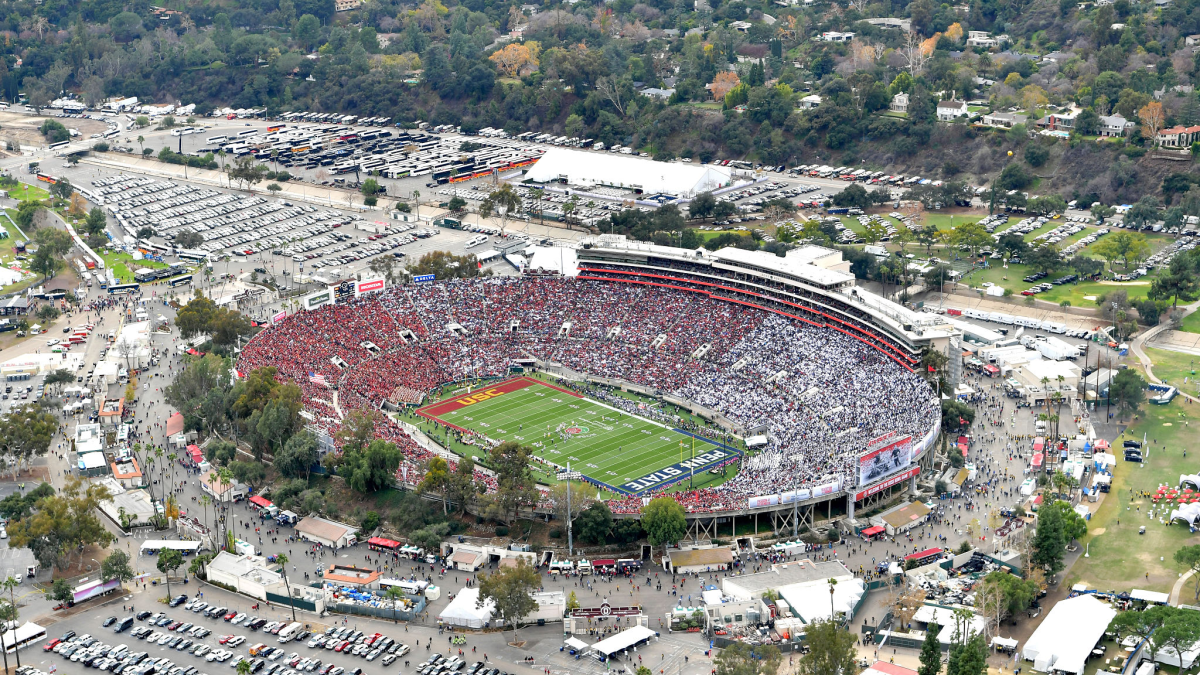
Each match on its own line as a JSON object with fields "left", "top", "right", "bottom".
{"left": 1021, "top": 596, "right": 1117, "bottom": 674}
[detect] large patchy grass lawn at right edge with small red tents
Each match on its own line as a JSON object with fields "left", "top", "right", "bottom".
{"left": 1066, "top": 396, "right": 1200, "bottom": 590}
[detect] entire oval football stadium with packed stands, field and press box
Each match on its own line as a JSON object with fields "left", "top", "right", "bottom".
{"left": 238, "top": 235, "right": 958, "bottom": 522}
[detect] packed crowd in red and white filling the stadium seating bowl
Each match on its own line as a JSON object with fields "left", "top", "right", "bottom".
{"left": 239, "top": 277, "right": 940, "bottom": 512}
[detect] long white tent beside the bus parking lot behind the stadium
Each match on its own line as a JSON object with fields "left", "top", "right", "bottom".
{"left": 526, "top": 148, "right": 732, "bottom": 197}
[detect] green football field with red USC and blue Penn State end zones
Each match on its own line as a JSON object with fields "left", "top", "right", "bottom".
{"left": 416, "top": 377, "right": 740, "bottom": 495}
